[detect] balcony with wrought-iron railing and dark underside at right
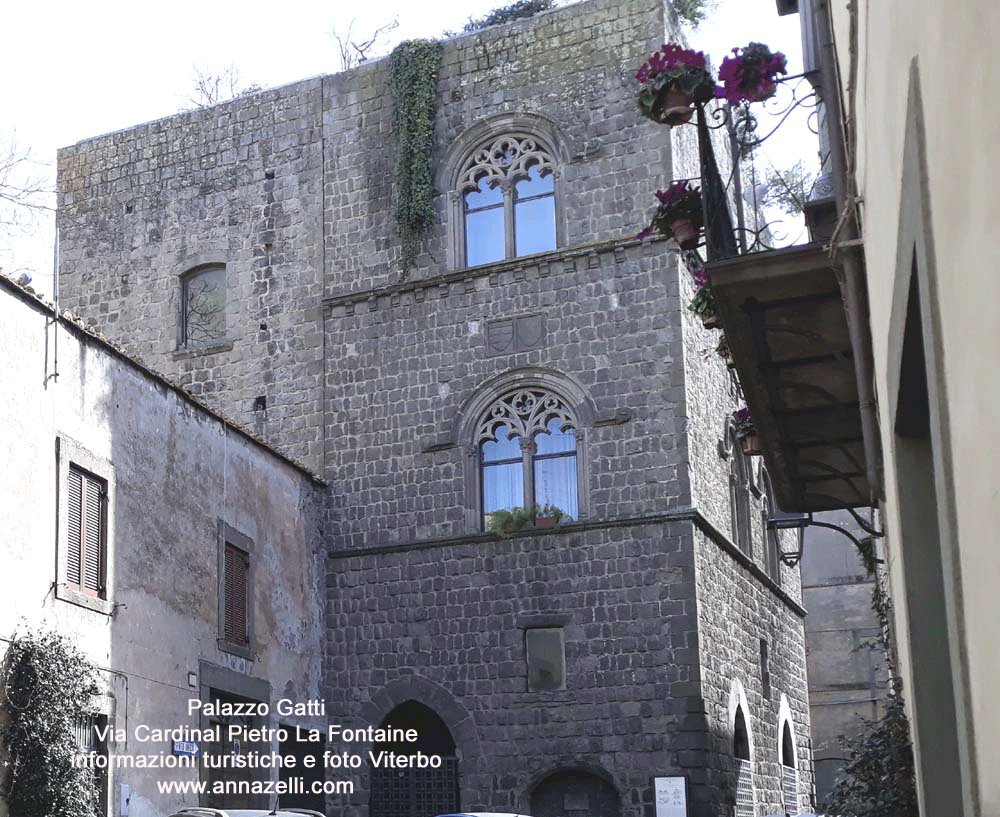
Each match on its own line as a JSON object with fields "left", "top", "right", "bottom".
{"left": 685, "top": 76, "right": 872, "bottom": 513}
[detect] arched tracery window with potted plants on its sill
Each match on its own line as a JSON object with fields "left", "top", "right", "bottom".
{"left": 476, "top": 388, "right": 580, "bottom": 526}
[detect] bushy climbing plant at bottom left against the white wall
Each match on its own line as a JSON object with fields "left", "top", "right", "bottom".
{"left": 0, "top": 633, "right": 97, "bottom": 817}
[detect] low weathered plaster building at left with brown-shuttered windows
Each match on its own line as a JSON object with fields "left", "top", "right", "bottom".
{"left": 0, "top": 276, "right": 325, "bottom": 817}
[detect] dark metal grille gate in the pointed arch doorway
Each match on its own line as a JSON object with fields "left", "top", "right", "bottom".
{"left": 371, "top": 757, "right": 459, "bottom": 817}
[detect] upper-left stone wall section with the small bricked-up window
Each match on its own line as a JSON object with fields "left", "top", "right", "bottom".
{"left": 58, "top": 80, "right": 323, "bottom": 470}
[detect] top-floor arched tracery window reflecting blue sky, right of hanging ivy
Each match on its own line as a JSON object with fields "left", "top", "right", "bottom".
{"left": 458, "top": 133, "right": 556, "bottom": 267}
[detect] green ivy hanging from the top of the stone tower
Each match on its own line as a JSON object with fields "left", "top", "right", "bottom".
{"left": 389, "top": 40, "right": 442, "bottom": 270}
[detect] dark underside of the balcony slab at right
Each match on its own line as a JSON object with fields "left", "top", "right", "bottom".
{"left": 705, "top": 244, "right": 869, "bottom": 513}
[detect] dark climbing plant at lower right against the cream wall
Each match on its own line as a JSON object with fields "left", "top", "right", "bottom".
{"left": 821, "top": 538, "right": 919, "bottom": 817}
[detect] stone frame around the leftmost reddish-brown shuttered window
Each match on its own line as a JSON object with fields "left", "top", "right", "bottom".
{"left": 54, "top": 434, "right": 117, "bottom": 616}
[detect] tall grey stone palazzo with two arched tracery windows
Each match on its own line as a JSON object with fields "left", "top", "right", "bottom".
{"left": 59, "top": 0, "right": 812, "bottom": 817}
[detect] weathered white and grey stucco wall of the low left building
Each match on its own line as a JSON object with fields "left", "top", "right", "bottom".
{"left": 0, "top": 283, "right": 324, "bottom": 817}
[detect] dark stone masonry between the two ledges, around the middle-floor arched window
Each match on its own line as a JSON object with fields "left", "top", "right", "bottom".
{"left": 325, "top": 242, "right": 689, "bottom": 547}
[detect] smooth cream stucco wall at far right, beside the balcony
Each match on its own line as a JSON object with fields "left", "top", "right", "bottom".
{"left": 833, "top": 0, "right": 1000, "bottom": 814}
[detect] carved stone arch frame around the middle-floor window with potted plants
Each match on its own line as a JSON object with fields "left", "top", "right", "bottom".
{"left": 453, "top": 368, "right": 596, "bottom": 532}
